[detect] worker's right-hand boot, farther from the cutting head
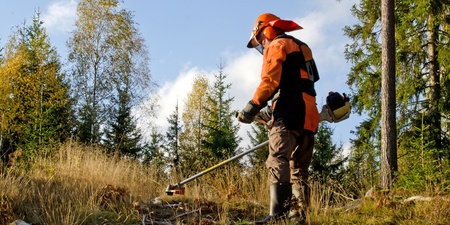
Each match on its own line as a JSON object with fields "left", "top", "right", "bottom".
{"left": 288, "top": 184, "right": 310, "bottom": 223}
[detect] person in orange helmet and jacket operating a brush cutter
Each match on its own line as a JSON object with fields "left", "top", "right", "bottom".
{"left": 236, "top": 13, "right": 319, "bottom": 223}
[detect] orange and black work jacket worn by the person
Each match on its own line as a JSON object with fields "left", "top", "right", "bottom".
{"left": 252, "top": 34, "right": 319, "bottom": 132}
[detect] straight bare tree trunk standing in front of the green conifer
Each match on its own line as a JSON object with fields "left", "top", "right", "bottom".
{"left": 381, "top": 0, "right": 397, "bottom": 189}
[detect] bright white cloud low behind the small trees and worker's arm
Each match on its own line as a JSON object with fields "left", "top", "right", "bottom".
{"left": 138, "top": 51, "right": 262, "bottom": 146}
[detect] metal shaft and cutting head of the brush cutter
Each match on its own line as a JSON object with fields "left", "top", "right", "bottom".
{"left": 166, "top": 141, "right": 269, "bottom": 195}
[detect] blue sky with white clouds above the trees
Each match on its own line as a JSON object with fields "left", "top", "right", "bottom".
{"left": 0, "top": 0, "right": 362, "bottom": 153}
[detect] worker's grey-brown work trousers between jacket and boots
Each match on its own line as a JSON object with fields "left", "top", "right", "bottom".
{"left": 266, "top": 120, "right": 314, "bottom": 186}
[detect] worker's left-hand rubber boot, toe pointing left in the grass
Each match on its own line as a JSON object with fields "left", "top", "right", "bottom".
{"left": 255, "top": 183, "right": 292, "bottom": 224}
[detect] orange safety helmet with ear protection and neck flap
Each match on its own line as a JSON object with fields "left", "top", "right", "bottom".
{"left": 247, "top": 13, "right": 303, "bottom": 48}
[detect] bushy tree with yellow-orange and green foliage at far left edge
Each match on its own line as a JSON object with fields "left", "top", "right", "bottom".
{"left": 0, "top": 12, "right": 73, "bottom": 160}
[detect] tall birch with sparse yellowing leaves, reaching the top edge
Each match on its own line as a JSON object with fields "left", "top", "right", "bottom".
{"left": 68, "top": 0, "right": 155, "bottom": 144}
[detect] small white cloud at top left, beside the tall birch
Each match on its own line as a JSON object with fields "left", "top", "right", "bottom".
{"left": 42, "top": 0, "right": 77, "bottom": 33}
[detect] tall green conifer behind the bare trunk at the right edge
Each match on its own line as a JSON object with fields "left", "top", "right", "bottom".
{"left": 345, "top": 0, "right": 450, "bottom": 190}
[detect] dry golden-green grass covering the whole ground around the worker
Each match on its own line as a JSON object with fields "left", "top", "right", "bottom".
{"left": 0, "top": 143, "right": 450, "bottom": 225}
